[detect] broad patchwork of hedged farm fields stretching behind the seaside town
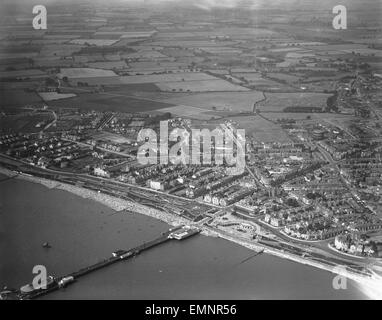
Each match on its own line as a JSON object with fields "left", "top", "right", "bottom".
{"left": 0, "top": 0, "right": 381, "bottom": 127}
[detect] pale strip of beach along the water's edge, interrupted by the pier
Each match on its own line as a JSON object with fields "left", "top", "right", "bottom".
{"left": 0, "top": 166, "right": 380, "bottom": 298}
